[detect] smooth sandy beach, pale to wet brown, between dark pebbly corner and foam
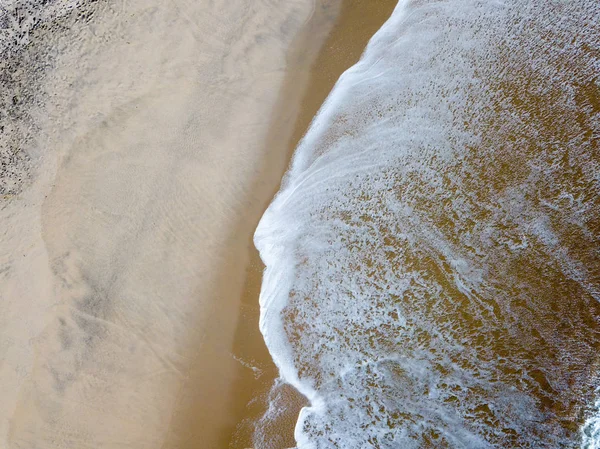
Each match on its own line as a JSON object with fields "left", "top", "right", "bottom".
{"left": 0, "top": 0, "right": 395, "bottom": 449}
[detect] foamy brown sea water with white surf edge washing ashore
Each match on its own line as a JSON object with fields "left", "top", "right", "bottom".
{"left": 255, "top": 0, "right": 600, "bottom": 449}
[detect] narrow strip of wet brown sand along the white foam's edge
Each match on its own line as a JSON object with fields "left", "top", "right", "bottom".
{"left": 158, "top": 0, "right": 397, "bottom": 449}
